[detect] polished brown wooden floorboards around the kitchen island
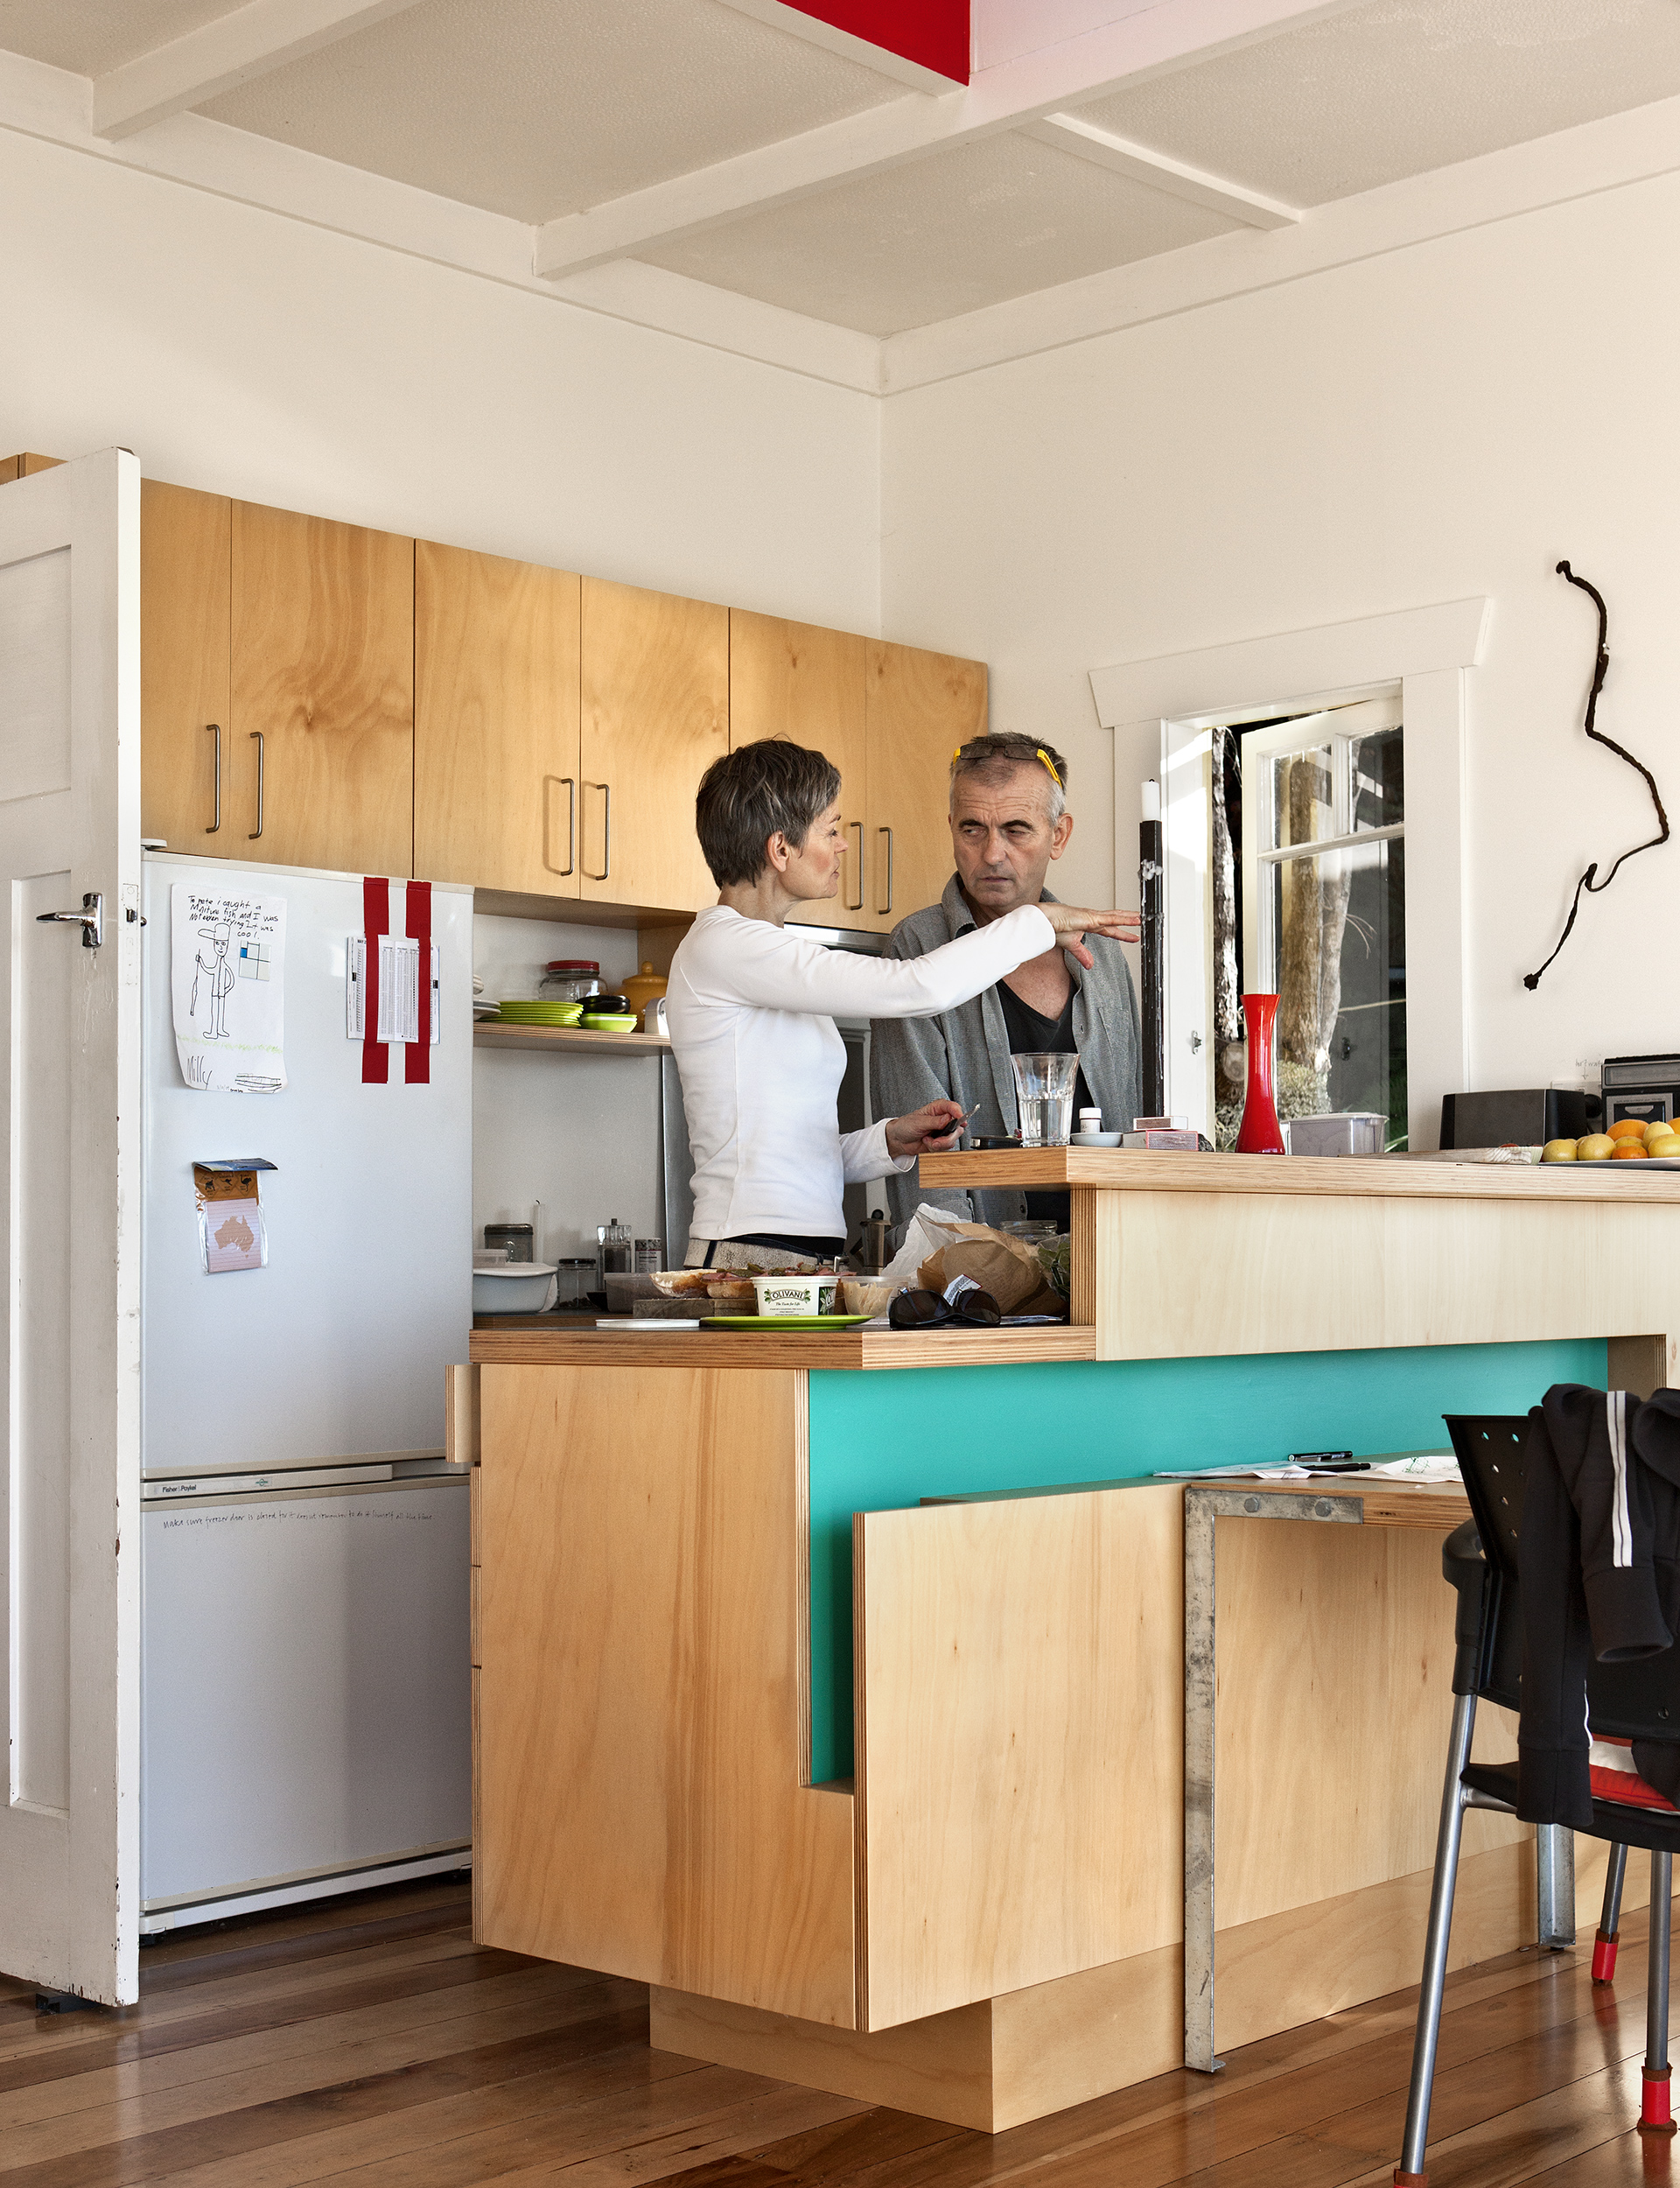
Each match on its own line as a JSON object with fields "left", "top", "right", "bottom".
{"left": 0, "top": 1880, "right": 1680, "bottom": 2188}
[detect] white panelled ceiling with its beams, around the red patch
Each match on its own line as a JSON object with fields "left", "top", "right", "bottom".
{"left": 0, "top": 0, "right": 1680, "bottom": 370}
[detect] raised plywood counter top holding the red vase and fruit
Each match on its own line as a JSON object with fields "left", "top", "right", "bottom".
{"left": 921, "top": 1147, "right": 1680, "bottom": 1208}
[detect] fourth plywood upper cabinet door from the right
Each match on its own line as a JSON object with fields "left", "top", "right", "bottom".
{"left": 414, "top": 541, "right": 582, "bottom": 897}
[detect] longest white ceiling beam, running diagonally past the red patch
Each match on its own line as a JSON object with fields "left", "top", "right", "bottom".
{"left": 534, "top": 0, "right": 1354, "bottom": 280}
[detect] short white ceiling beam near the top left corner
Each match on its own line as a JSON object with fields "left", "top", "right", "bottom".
{"left": 94, "top": 0, "right": 433, "bottom": 143}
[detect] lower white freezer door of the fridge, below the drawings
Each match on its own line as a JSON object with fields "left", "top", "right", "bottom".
{"left": 140, "top": 1477, "right": 472, "bottom": 1919}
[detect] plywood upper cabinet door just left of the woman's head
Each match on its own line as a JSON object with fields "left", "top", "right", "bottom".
{"left": 578, "top": 578, "right": 729, "bottom": 913}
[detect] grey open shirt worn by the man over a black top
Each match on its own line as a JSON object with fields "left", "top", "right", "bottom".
{"left": 869, "top": 875, "right": 1138, "bottom": 1252}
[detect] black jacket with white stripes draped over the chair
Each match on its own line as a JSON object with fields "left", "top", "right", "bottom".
{"left": 1516, "top": 1383, "right": 1680, "bottom": 1829}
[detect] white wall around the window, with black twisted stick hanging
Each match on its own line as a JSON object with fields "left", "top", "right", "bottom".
{"left": 882, "top": 178, "right": 1680, "bottom": 1112}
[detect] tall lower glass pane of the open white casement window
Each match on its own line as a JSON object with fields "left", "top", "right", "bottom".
{"left": 1263, "top": 827, "right": 1407, "bottom": 1149}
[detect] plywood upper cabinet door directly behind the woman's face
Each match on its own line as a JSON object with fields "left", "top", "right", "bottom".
{"left": 729, "top": 608, "right": 871, "bottom": 928}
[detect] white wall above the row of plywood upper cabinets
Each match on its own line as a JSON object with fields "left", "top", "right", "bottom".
{"left": 0, "top": 131, "right": 879, "bottom": 633}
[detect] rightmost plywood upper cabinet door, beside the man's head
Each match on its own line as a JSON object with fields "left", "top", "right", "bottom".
{"left": 864, "top": 639, "right": 987, "bottom": 932}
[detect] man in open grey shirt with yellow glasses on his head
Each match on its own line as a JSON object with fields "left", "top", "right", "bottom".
{"left": 871, "top": 735, "right": 1140, "bottom": 1228}
